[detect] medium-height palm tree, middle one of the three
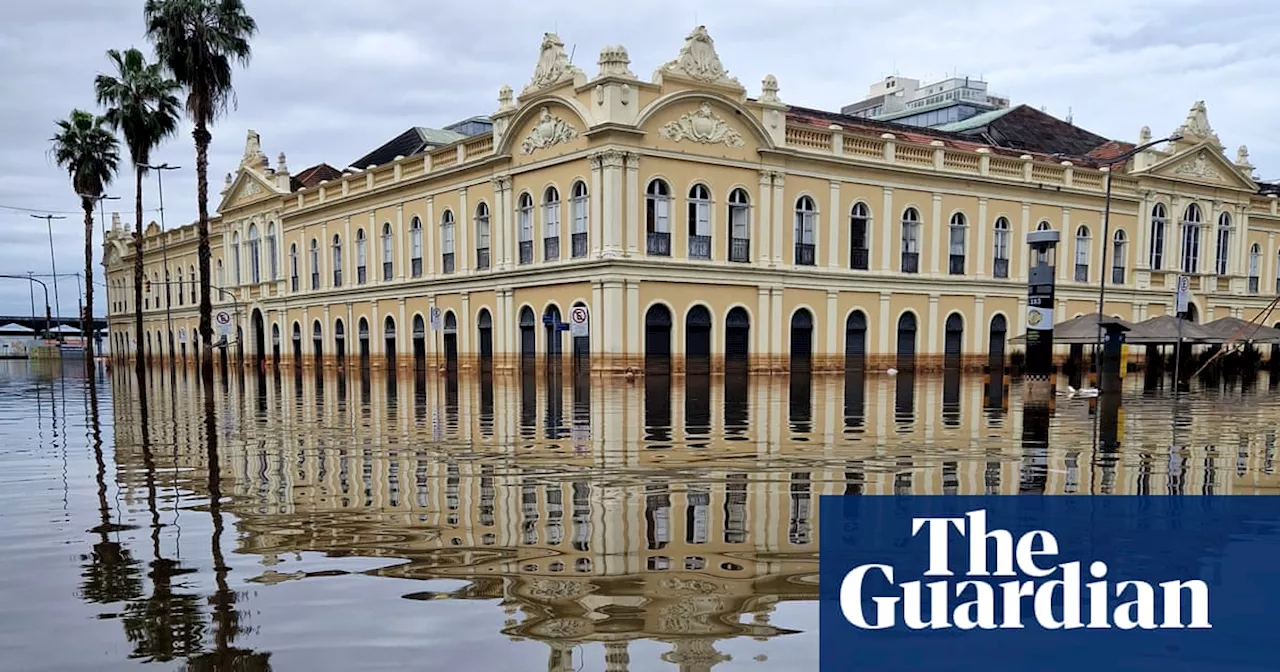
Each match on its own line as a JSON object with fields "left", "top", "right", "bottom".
{"left": 93, "top": 49, "right": 182, "bottom": 381}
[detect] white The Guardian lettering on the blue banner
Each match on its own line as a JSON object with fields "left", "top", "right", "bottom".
{"left": 840, "top": 509, "right": 1212, "bottom": 630}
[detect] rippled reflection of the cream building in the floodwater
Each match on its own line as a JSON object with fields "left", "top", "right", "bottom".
{"left": 99, "top": 362, "right": 1280, "bottom": 671}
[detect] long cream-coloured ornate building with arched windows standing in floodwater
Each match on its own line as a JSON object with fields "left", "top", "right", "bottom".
{"left": 105, "top": 27, "right": 1280, "bottom": 371}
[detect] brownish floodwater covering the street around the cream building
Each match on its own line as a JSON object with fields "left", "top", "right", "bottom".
{"left": 0, "top": 362, "right": 1280, "bottom": 672}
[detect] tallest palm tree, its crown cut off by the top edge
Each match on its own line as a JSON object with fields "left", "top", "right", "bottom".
{"left": 142, "top": 0, "right": 257, "bottom": 380}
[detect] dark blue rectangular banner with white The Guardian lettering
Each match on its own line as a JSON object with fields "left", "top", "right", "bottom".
{"left": 819, "top": 497, "right": 1280, "bottom": 672}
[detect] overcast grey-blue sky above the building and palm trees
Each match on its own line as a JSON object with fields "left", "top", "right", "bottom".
{"left": 0, "top": 0, "right": 1280, "bottom": 316}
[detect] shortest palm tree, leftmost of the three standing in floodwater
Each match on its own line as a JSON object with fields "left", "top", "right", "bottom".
{"left": 50, "top": 110, "right": 120, "bottom": 366}
